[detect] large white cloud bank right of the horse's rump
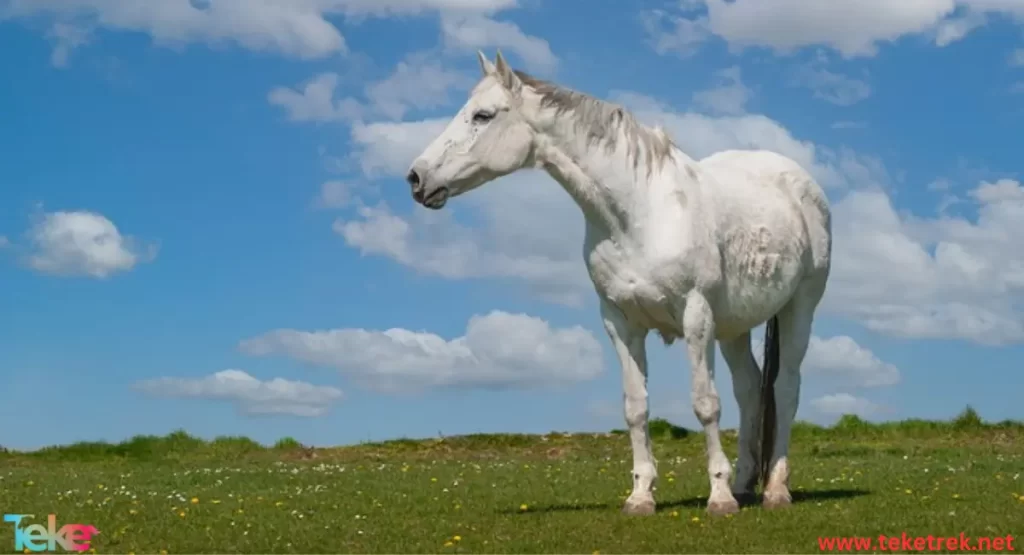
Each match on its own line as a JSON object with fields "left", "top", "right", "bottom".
{"left": 825, "top": 179, "right": 1024, "bottom": 344}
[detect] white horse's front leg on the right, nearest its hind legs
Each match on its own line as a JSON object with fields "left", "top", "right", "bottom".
{"left": 683, "top": 292, "right": 739, "bottom": 516}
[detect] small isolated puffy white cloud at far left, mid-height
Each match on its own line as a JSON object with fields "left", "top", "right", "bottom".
{"left": 28, "top": 211, "right": 157, "bottom": 279}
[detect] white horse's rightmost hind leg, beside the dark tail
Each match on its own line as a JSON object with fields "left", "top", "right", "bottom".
{"left": 760, "top": 282, "right": 824, "bottom": 509}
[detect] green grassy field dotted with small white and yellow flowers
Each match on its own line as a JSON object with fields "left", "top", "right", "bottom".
{"left": 0, "top": 411, "right": 1024, "bottom": 553}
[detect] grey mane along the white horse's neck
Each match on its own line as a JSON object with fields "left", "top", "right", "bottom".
{"left": 513, "top": 70, "right": 677, "bottom": 174}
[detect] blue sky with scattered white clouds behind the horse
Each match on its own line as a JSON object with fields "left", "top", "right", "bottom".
{"left": 0, "top": 0, "right": 1024, "bottom": 447}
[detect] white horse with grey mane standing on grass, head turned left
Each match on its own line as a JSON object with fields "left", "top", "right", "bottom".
{"left": 407, "top": 51, "right": 831, "bottom": 515}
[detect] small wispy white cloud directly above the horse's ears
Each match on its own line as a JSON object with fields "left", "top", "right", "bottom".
{"left": 441, "top": 13, "right": 558, "bottom": 75}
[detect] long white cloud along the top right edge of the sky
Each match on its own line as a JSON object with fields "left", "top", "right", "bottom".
{"left": 642, "top": 0, "right": 1024, "bottom": 57}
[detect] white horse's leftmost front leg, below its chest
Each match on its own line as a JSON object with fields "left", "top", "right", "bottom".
{"left": 601, "top": 299, "right": 657, "bottom": 515}
